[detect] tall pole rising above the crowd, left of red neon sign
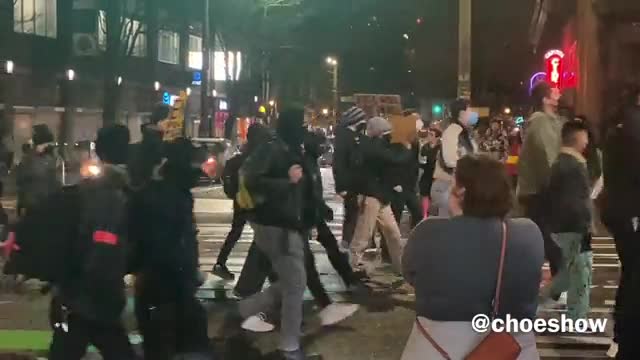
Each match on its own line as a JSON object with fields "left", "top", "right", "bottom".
{"left": 458, "top": 0, "right": 472, "bottom": 99}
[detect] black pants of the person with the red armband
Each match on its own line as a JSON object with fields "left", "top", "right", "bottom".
{"left": 49, "top": 297, "right": 136, "bottom": 360}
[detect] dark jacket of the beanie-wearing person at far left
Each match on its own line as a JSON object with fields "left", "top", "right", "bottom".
{"left": 16, "top": 152, "right": 62, "bottom": 209}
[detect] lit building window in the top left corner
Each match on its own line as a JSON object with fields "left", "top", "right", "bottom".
{"left": 13, "top": 0, "right": 58, "bottom": 38}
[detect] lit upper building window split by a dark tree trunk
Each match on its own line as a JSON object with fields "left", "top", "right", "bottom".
{"left": 98, "top": 10, "right": 147, "bottom": 57}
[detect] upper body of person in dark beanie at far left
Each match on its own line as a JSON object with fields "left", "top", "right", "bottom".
{"left": 16, "top": 124, "right": 62, "bottom": 215}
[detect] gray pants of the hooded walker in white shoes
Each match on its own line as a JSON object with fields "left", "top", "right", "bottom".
{"left": 239, "top": 223, "right": 307, "bottom": 351}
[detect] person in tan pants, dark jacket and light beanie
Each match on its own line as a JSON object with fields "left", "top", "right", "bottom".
{"left": 351, "top": 117, "right": 411, "bottom": 272}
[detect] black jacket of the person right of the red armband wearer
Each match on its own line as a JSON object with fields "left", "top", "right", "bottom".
{"left": 129, "top": 180, "right": 198, "bottom": 302}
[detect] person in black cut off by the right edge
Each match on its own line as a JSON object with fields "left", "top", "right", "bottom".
{"left": 603, "top": 90, "right": 640, "bottom": 359}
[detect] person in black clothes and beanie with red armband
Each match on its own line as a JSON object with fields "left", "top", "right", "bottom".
{"left": 49, "top": 125, "right": 135, "bottom": 360}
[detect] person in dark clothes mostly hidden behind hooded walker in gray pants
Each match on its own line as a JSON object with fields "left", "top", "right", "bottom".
{"left": 211, "top": 124, "right": 271, "bottom": 280}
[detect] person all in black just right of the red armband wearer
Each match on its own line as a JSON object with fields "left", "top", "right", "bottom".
{"left": 130, "top": 139, "right": 211, "bottom": 360}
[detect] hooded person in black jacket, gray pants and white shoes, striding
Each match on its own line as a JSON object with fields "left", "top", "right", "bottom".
{"left": 230, "top": 109, "right": 322, "bottom": 360}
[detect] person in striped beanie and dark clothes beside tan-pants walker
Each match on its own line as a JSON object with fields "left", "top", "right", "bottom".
{"left": 333, "top": 106, "right": 367, "bottom": 246}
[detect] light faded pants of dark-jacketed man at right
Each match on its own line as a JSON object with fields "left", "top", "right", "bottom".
{"left": 550, "top": 233, "right": 593, "bottom": 319}
